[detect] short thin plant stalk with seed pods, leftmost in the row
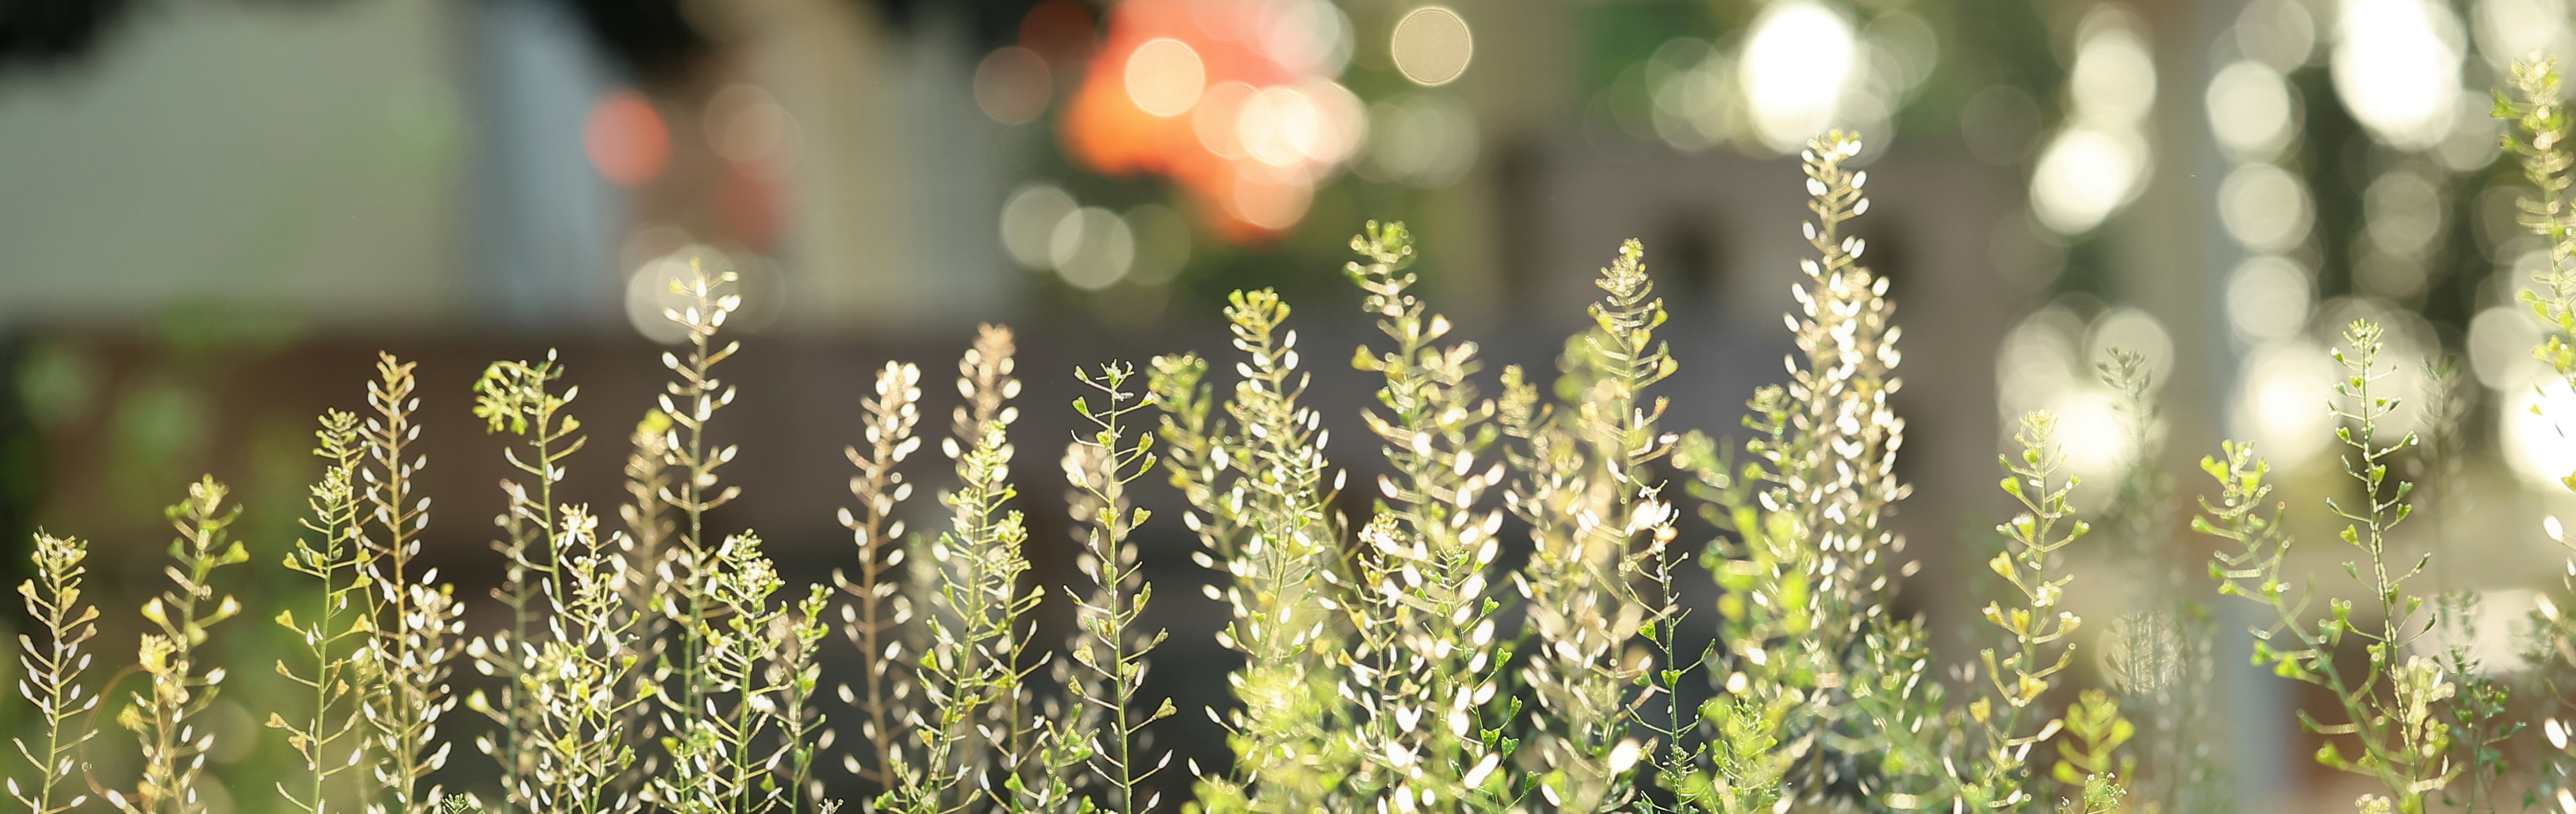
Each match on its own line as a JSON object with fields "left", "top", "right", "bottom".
{"left": 8, "top": 531, "right": 98, "bottom": 814}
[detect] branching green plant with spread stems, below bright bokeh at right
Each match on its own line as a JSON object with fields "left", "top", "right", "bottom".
{"left": 2192, "top": 319, "right": 2460, "bottom": 814}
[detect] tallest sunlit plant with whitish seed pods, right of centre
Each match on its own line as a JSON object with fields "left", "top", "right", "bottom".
{"left": 1674, "top": 131, "right": 1955, "bottom": 811}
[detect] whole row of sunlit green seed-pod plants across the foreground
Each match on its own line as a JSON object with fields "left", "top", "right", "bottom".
{"left": 45, "top": 64, "right": 2576, "bottom": 814}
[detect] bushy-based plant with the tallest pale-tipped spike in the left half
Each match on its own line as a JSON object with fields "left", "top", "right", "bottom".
{"left": 620, "top": 268, "right": 827, "bottom": 814}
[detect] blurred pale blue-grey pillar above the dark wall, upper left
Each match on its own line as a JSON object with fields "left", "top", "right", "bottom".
{"left": 464, "top": 0, "right": 624, "bottom": 335}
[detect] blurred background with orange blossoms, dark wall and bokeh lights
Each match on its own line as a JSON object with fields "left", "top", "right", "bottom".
{"left": 0, "top": 0, "right": 2576, "bottom": 811}
